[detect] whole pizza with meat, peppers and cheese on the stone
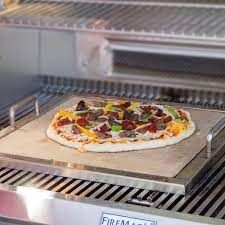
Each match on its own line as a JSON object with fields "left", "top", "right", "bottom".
{"left": 47, "top": 99, "right": 195, "bottom": 152}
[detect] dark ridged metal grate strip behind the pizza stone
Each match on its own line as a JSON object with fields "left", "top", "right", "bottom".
{"left": 41, "top": 76, "right": 225, "bottom": 109}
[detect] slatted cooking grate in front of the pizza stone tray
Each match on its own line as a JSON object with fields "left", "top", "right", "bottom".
{"left": 0, "top": 151, "right": 225, "bottom": 219}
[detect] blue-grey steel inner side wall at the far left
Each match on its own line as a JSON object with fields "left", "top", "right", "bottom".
{"left": 0, "top": 27, "right": 39, "bottom": 74}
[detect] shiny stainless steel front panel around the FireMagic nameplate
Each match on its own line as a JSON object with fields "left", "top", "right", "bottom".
{"left": 0, "top": 185, "right": 224, "bottom": 225}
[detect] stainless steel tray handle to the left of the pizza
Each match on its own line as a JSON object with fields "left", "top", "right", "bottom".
{"left": 9, "top": 96, "right": 40, "bottom": 129}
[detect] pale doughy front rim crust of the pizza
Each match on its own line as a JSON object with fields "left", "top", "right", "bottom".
{"left": 47, "top": 118, "right": 195, "bottom": 152}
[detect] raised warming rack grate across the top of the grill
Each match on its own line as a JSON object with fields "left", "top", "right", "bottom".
{"left": 0, "top": 0, "right": 225, "bottom": 41}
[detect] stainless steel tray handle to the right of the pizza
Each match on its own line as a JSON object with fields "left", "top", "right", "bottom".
{"left": 207, "top": 117, "right": 225, "bottom": 158}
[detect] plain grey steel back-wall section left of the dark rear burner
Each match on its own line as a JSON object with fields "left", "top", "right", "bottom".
{"left": 40, "top": 30, "right": 76, "bottom": 77}
